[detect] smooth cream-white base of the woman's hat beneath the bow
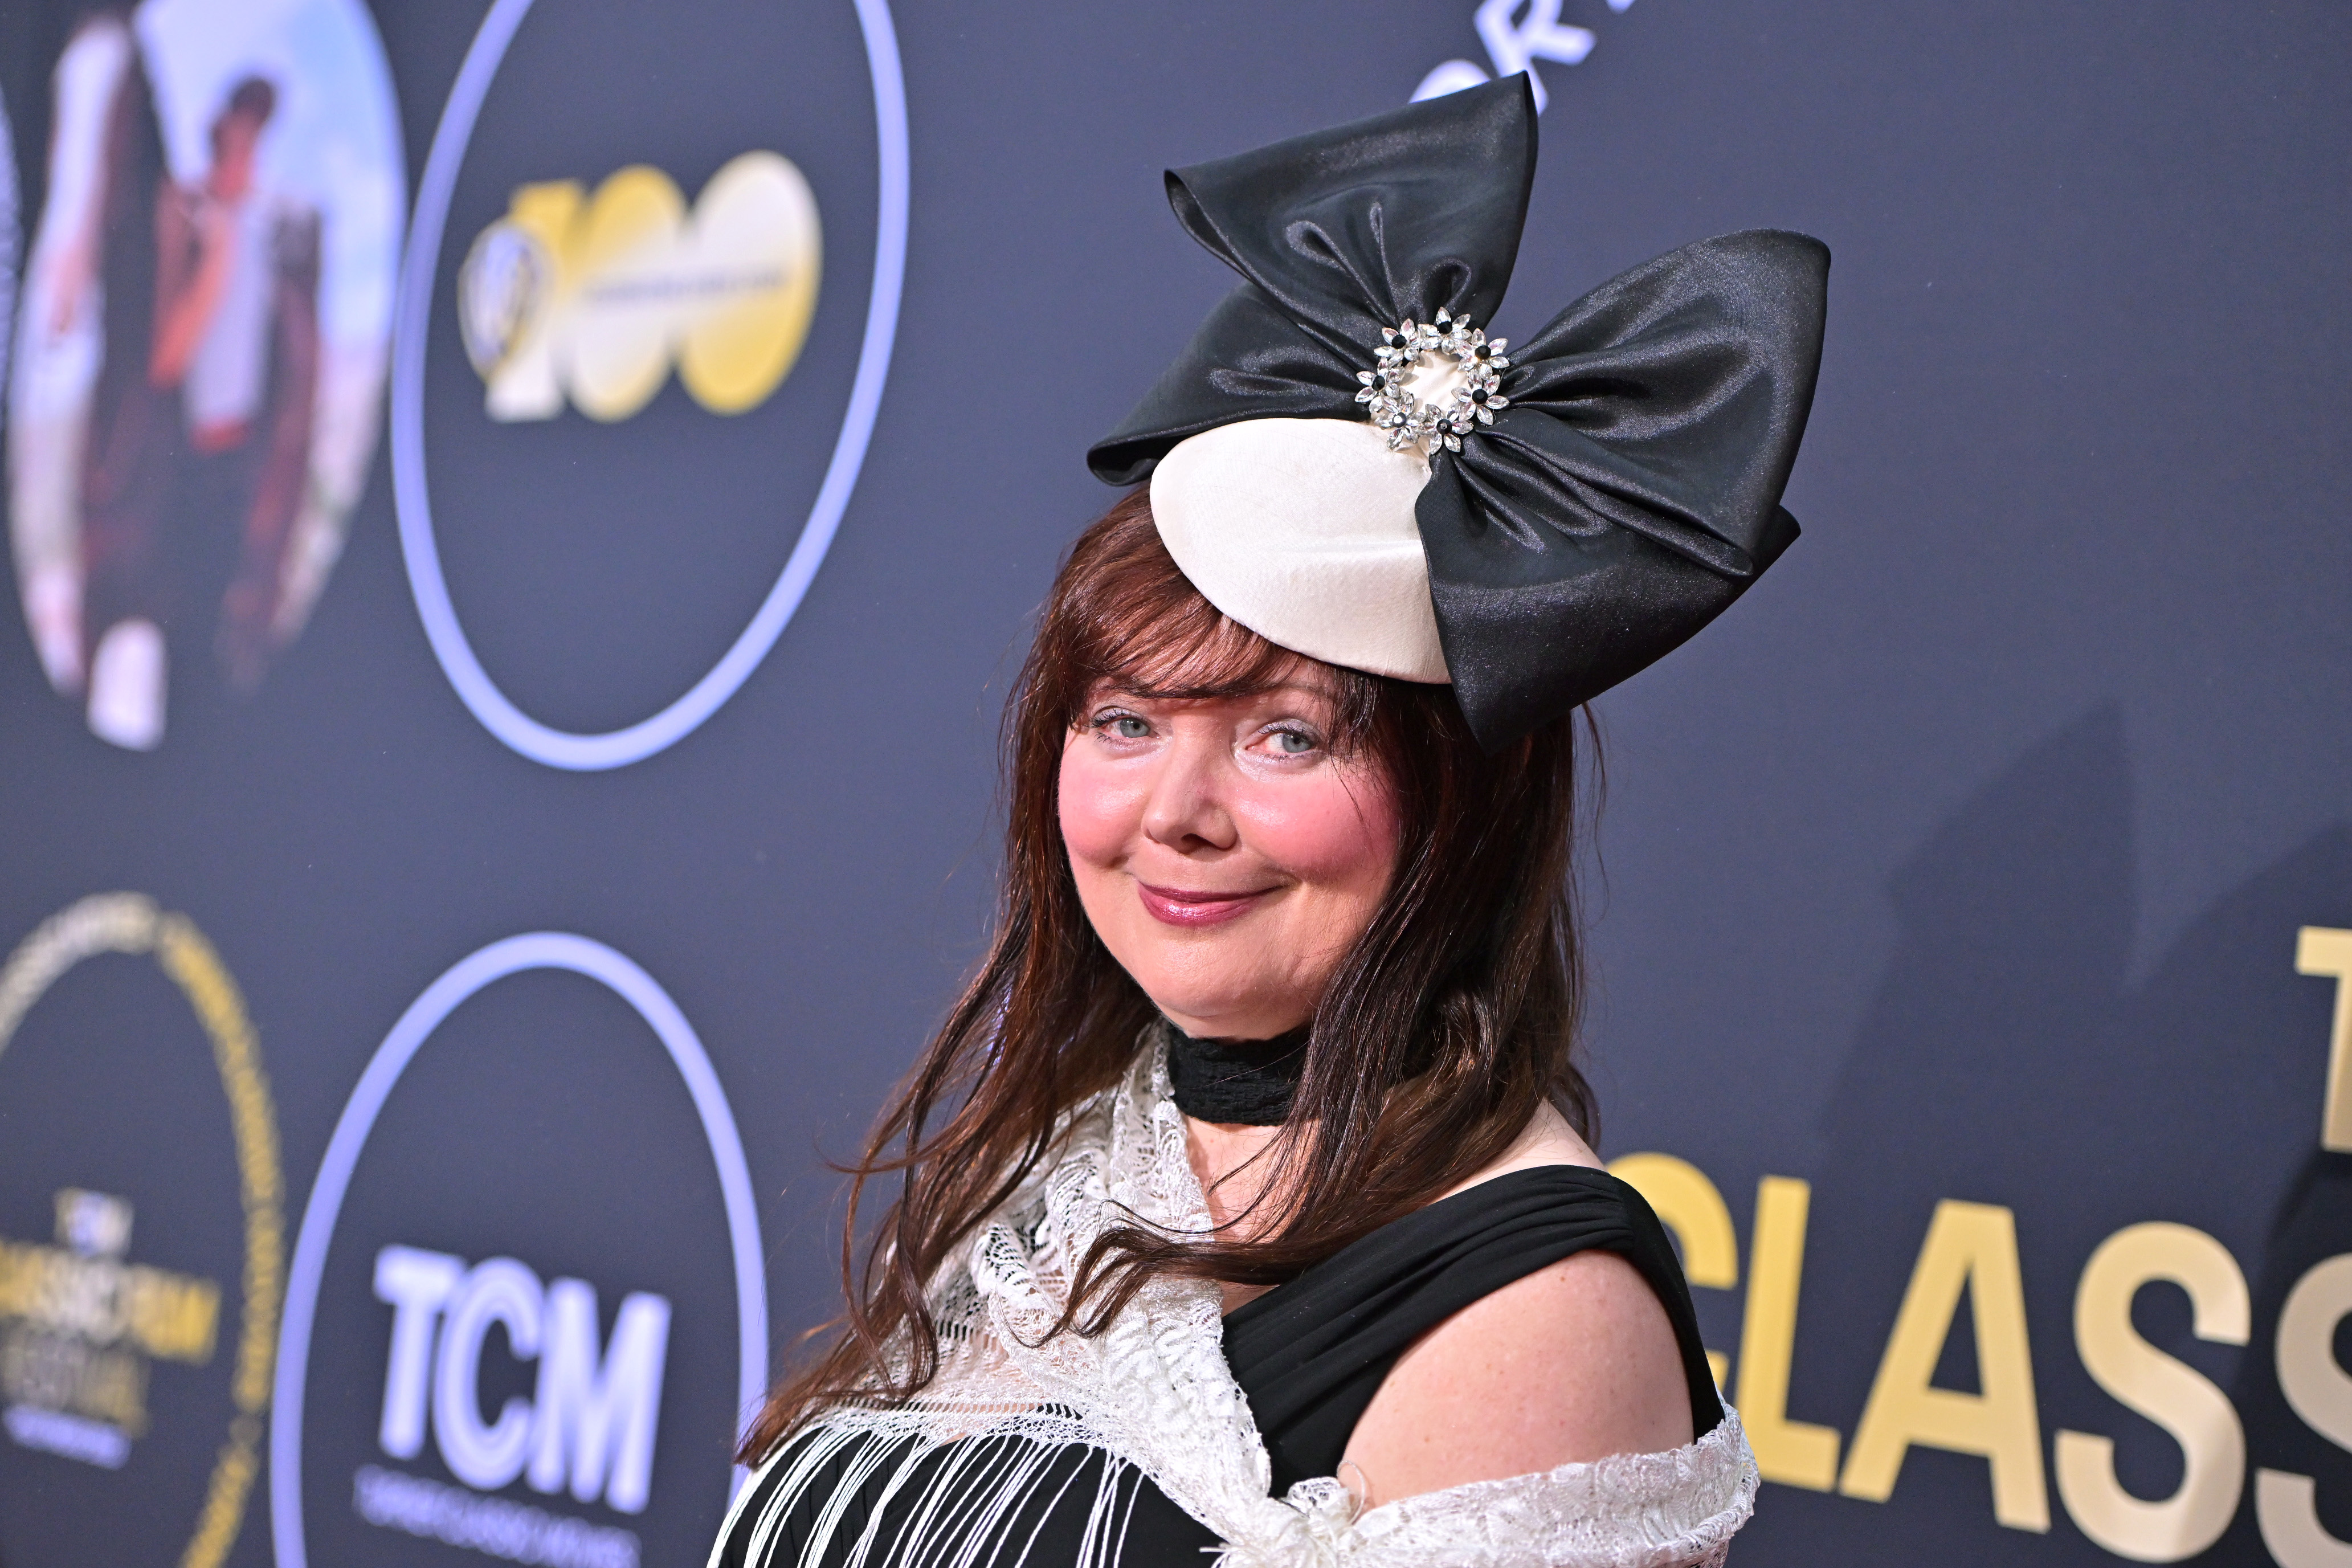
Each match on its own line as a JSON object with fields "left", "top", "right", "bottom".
{"left": 1153, "top": 418, "right": 1449, "bottom": 684}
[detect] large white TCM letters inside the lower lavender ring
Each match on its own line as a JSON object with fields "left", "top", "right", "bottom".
{"left": 376, "top": 1246, "right": 670, "bottom": 1514}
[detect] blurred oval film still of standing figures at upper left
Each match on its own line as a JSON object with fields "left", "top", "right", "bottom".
{"left": 7, "top": 0, "right": 405, "bottom": 750}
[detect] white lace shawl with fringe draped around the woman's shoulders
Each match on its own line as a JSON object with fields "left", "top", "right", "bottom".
{"left": 713, "top": 1044, "right": 1757, "bottom": 1568}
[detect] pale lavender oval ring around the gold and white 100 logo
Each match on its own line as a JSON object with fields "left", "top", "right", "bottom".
{"left": 390, "top": 0, "right": 908, "bottom": 771}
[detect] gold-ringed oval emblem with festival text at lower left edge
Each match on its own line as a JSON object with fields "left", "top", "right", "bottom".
{"left": 0, "top": 893, "right": 284, "bottom": 1568}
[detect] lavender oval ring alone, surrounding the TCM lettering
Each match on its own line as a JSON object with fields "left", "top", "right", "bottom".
{"left": 271, "top": 931, "right": 767, "bottom": 1568}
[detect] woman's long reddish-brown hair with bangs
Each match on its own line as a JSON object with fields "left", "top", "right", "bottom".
{"left": 738, "top": 489, "right": 1597, "bottom": 1464}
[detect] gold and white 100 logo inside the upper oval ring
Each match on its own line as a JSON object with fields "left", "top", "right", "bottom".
{"left": 456, "top": 153, "right": 823, "bottom": 421}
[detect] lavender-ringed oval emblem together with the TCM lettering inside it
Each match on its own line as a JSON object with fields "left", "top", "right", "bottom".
{"left": 271, "top": 931, "right": 767, "bottom": 1568}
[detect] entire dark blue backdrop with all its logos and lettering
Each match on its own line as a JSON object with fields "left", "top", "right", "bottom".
{"left": 0, "top": 0, "right": 2352, "bottom": 1568}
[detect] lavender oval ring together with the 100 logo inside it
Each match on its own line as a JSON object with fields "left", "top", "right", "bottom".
{"left": 390, "top": 0, "right": 908, "bottom": 771}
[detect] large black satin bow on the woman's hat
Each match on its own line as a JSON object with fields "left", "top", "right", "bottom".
{"left": 1087, "top": 77, "right": 1830, "bottom": 748}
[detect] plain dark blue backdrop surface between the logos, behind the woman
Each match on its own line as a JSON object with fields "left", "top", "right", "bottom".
{"left": 0, "top": 0, "right": 2352, "bottom": 1568}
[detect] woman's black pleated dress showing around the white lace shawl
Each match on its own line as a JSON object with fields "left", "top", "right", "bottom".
{"left": 715, "top": 1166, "right": 1724, "bottom": 1568}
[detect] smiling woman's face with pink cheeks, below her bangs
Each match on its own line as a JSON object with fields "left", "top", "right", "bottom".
{"left": 1061, "top": 663, "right": 1397, "bottom": 1039}
